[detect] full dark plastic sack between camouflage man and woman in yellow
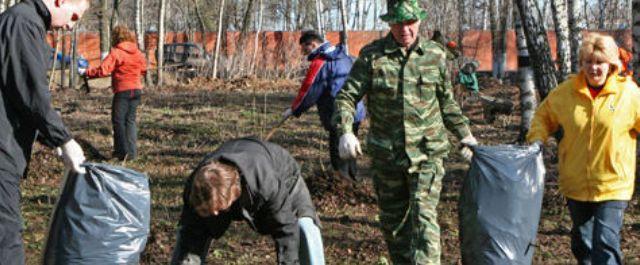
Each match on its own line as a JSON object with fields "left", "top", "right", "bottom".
{"left": 459, "top": 145, "right": 545, "bottom": 265}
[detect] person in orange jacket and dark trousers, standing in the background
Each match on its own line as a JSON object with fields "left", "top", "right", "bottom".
{"left": 81, "top": 26, "right": 147, "bottom": 160}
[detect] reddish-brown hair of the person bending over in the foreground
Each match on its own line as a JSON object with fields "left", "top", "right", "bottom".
{"left": 189, "top": 161, "right": 241, "bottom": 213}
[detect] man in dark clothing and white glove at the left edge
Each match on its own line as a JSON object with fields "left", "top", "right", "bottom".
{"left": 0, "top": 0, "right": 89, "bottom": 265}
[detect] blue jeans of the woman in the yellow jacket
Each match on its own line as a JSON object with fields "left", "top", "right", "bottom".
{"left": 567, "top": 199, "right": 628, "bottom": 265}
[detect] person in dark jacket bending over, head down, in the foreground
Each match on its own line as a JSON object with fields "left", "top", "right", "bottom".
{"left": 171, "top": 138, "right": 324, "bottom": 264}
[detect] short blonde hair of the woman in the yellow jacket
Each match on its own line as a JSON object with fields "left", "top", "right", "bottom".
{"left": 579, "top": 33, "right": 621, "bottom": 73}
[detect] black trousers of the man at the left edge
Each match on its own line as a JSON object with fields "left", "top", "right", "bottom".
{"left": 0, "top": 170, "right": 25, "bottom": 265}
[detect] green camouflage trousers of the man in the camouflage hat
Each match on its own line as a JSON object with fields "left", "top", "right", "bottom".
{"left": 372, "top": 159, "right": 444, "bottom": 265}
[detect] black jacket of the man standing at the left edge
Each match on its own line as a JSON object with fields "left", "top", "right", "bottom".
{"left": 0, "top": 0, "right": 71, "bottom": 177}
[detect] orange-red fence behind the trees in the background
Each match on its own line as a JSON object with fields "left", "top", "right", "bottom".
{"left": 48, "top": 30, "right": 632, "bottom": 71}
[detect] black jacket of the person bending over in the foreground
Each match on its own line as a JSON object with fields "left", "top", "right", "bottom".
{"left": 178, "top": 138, "right": 319, "bottom": 264}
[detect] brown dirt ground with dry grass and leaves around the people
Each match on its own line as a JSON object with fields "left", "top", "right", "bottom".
{"left": 22, "top": 75, "right": 640, "bottom": 264}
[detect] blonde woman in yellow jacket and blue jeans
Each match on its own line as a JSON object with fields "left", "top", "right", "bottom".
{"left": 527, "top": 33, "right": 640, "bottom": 265}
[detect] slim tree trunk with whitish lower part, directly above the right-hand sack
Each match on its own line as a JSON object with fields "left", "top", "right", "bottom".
{"left": 513, "top": 6, "right": 537, "bottom": 143}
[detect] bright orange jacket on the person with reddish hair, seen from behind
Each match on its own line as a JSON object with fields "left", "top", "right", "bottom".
{"left": 86, "top": 42, "right": 147, "bottom": 94}
